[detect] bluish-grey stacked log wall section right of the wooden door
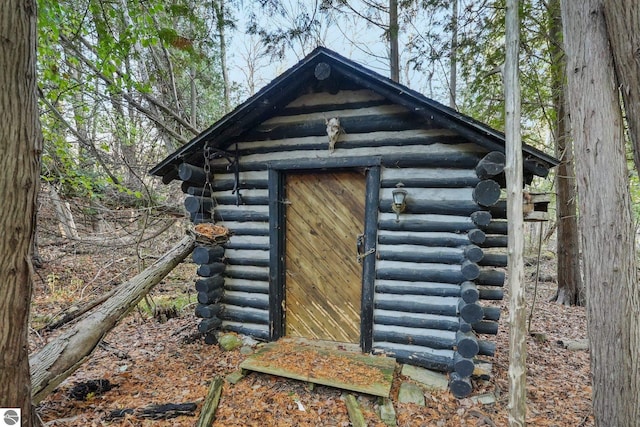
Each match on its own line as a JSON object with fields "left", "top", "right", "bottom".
{"left": 373, "top": 154, "right": 506, "bottom": 395}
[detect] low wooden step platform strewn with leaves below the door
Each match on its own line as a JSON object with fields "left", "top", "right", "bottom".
{"left": 240, "top": 338, "right": 396, "bottom": 397}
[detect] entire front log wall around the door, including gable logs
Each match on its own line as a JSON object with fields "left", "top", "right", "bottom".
{"left": 175, "top": 90, "right": 506, "bottom": 398}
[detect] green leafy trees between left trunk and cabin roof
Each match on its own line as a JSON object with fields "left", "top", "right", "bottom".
{"left": 38, "top": 0, "right": 230, "bottom": 203}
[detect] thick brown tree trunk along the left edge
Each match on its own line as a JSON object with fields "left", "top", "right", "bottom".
{"left": 0, "top": 0, "right": 42, "bottom": 426}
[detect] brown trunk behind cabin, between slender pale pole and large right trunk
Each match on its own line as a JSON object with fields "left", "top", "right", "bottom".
{"left": 549, "top": 0, "right": 585, "bottom": 305}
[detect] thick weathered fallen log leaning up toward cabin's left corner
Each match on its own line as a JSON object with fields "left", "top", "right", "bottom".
{"left": 29, "top": 235, "right": 195, "bottom": 404}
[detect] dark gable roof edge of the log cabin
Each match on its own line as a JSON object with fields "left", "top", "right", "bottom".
{"left": 150, "top": 47, "right": 559, "bottom": 182}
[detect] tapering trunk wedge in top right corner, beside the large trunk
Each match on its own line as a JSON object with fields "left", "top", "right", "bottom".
{"left": 604, "top": 0, "right": 640, "bottom": 173}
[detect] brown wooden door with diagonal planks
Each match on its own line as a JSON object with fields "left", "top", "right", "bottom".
{"left": 285, "top": 172, "right": 365, "bottom": 343}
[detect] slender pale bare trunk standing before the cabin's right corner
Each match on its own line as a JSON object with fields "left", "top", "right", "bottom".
{"left": 504, "top": 0, "right": 527, "bottom": 427}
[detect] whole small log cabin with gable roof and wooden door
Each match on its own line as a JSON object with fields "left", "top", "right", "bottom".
{"left": 151, "top": 47, "right": 558, "bottom": 395}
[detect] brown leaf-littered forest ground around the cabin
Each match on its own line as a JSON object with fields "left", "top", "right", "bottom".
{"left": 31, "top": 216, "right": 594, "bottom": 427}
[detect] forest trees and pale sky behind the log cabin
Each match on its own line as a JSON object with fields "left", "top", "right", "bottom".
{"left": 1, "top": 0, "right": 640, "bottom": 426}
